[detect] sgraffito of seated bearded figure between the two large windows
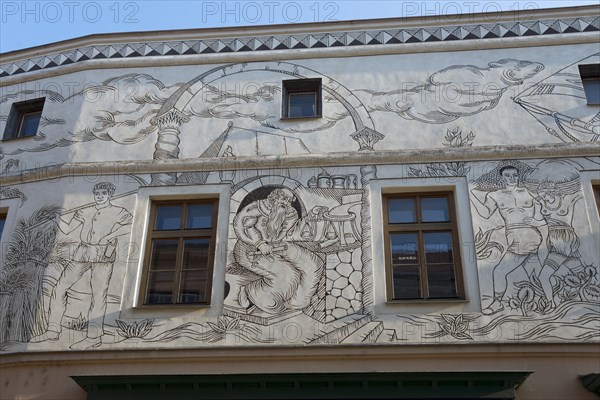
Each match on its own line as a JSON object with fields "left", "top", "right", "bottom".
{"left": 225, "top": 175, "right": 362, "bottom": 322}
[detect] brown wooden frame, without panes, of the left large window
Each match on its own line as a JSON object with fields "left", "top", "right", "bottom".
{"left": 140, "top": 198, "right": 219, "bottom": 307}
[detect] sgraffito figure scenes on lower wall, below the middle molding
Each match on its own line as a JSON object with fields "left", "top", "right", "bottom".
{"left": 0, "top": 155, "right": 600, "bottom": 351}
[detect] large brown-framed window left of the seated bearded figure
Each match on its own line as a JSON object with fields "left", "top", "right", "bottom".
{"left": 142, "top": 199, "right": 218, "bottom": 304}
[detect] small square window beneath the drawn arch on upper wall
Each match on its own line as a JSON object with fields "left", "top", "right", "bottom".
{"left": 282, "top": 79, "right": 322, "bottom": 118}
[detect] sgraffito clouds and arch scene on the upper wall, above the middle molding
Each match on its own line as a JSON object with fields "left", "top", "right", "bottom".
{"left": 0, "top": 54, "right": 600, "bottom": 166}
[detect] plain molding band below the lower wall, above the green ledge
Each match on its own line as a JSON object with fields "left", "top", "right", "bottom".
{"left": 0, "top": 342, "right": 597, "bottom": 373}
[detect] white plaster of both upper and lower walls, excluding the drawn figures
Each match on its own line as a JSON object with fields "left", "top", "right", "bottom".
{"left": 0, "top": 36, "right": 600, "bottom": 351}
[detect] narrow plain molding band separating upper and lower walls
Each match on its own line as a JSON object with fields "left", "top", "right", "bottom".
{"left": 0, "top": 142, "right": 600, "bottom": 185}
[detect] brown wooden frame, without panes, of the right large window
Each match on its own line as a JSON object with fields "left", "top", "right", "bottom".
{"left": 383, "top": 191, "right": 466, "bottom": 303}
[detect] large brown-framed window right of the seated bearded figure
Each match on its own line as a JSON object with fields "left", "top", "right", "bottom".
{"left": 383, "top": 192, "right": 464, "bottom": 300}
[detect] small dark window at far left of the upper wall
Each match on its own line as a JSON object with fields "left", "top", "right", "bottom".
{"left": 3, "top": 98, "right": 46, "bottom": 140}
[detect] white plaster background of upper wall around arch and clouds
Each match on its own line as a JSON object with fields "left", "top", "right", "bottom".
{"left": 0, "top": 44, "right": 598, "bottom": 173}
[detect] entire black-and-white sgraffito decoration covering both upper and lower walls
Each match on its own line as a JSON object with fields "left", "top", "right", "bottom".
{"left": 0, "top": 54, "right": 600, "bottom": 352}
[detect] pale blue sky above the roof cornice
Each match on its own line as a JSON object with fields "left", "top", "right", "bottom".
{"left": 0, "top": 0, "right": 598, "bottom": 52}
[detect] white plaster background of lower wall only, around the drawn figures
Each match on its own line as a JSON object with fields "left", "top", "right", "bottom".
{"left": 0, "top": 157, "right": 600, "bottom": 352}
